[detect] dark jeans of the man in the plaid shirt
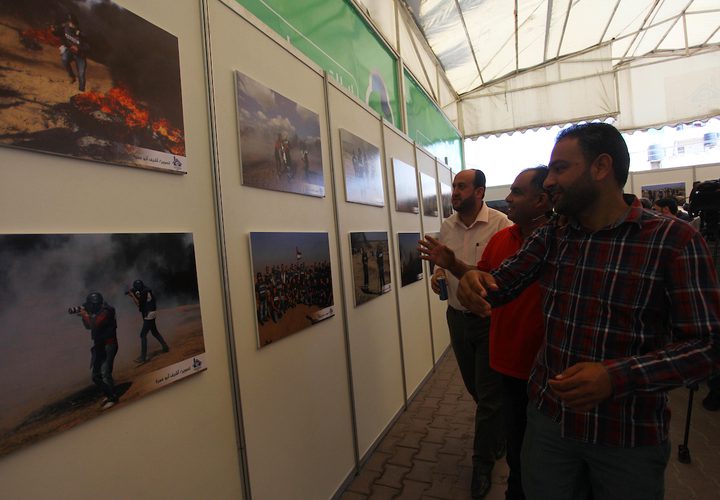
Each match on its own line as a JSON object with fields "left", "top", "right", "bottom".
{"left": 522, "top": 402, "right": 670, "bottom": 500}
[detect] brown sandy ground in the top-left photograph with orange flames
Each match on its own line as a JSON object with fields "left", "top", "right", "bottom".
{"left": 0, "top": 17, "right": 112, "bottom": 139}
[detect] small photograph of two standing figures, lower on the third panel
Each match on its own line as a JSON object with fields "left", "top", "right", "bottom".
{"left": 350, "top": 231, "right": 392, "bottom": 306}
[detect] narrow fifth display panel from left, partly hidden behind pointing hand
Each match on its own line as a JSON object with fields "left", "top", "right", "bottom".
{"left": 416, "top": 152, "right": 450, "bottom": 363}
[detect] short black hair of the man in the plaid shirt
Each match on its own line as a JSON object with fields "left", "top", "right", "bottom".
{"left": 555, "top": 122, "right": 630, "bottom": 187}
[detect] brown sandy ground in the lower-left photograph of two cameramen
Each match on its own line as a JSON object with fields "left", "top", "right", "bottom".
{"left": 0, "top": 305, "right": 205, "bottom": 456}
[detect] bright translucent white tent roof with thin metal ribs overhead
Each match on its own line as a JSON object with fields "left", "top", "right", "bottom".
{"left": 402, "top": 0, "right": 720, "bottom": 98}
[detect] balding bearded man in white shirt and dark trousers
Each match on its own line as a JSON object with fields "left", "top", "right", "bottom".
{"left": 421, "top": 169, "right": 512, "bottom": 498}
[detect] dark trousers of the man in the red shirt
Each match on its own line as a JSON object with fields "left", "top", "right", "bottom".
{"left": 502, "top": 375, "right": 528, "bottom": 500}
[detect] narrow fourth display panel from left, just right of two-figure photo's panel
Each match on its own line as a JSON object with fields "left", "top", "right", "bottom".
{"left": 383, "top": 124, "right": 433, "bottom": 401}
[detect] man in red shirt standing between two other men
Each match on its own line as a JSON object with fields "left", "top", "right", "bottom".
{"left": 477, "top": 166, "right": 552, "bottom": 500}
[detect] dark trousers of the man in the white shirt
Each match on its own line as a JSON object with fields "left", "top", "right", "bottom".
{"left": 447, "top": 307, "right": 505, "bottom": 473}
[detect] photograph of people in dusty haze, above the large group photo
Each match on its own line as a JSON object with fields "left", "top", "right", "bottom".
{"left": 235, "top": 71, "right": 325, "bottom": 197}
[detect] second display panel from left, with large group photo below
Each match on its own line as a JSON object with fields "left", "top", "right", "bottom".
{"left": 208, "top": 0, "right": 356, "bottom": 499}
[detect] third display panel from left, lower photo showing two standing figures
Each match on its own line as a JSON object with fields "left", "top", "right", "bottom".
{"left": 328, "top": 80, "right": 404, "bottom": 459}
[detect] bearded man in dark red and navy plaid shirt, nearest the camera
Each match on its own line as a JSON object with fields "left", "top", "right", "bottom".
{"left": 458, "top": 123, "right": 720, "bottom": 500}
